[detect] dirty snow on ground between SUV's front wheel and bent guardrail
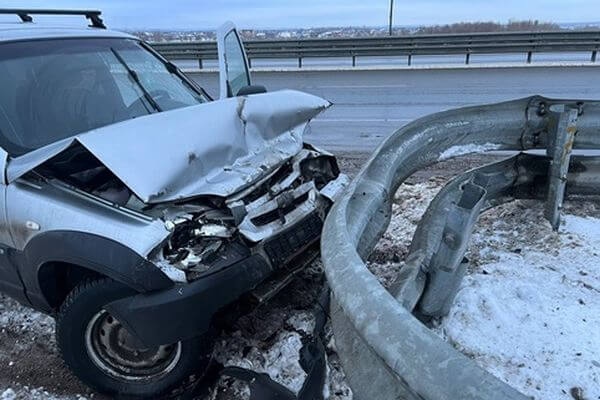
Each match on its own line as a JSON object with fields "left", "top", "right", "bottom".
{"left": 211, "top": 262, "right": 352, "bottom": 400}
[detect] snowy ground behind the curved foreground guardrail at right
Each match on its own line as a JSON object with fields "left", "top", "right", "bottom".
{"left": 380, "top": 178, "right": 600, "bottom": 400}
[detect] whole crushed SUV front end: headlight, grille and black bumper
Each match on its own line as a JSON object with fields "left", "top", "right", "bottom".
{"left": 108, "top": 145, "right": 348, "bottom": 345}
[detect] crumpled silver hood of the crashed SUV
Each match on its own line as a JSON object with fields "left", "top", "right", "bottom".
{"left": 6, "top": 90, "right": 330, "bottom": 203}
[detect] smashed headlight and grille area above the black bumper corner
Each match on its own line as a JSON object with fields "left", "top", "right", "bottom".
{"left": 155, "top": 147, "right": 347, "bottom": 282}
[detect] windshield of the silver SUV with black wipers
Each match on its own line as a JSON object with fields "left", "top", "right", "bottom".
{"left": 0, "top": 38, "right": 208, "bottom": 156}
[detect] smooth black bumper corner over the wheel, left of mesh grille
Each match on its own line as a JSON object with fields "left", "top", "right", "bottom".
{"left": 106, "top": 255, "right": 273, "bottom": 347}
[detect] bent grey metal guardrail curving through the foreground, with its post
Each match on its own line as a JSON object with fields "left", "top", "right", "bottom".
{"left": 321, "top": 96, "right": 600, "bottom": 400}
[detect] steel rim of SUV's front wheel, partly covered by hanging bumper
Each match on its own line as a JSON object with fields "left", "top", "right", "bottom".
{"left": 85, "top": 310, "right": 181, "bottom": 381}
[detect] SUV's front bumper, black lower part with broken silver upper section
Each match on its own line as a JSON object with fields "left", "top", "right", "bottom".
{"left": 106, "top": 161, "right": 348, "bottom": 346}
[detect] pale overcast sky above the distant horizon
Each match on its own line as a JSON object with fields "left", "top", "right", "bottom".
{"left": 0, "top": 0, "right": 600, "bottom": 30}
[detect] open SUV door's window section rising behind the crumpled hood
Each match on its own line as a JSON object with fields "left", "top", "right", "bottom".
{"left": 217, "top": 22, "right": 252, "bottom": 99}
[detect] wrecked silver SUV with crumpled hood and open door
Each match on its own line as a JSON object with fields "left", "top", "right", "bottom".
{"left": 0, "top": 10, "right": 346, "bottom": 397}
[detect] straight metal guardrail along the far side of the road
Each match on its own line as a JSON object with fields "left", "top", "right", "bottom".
{"left": 152, "top": 31, "right": 600, "bottom": 68}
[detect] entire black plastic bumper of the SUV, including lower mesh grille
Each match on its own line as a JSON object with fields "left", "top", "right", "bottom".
{"left": 105, "top": 212, "right": 330, "bottom": 347}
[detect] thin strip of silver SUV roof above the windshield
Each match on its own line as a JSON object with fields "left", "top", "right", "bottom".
{"left": 0, "top": 22, "right": 136, "bottom": 43}
